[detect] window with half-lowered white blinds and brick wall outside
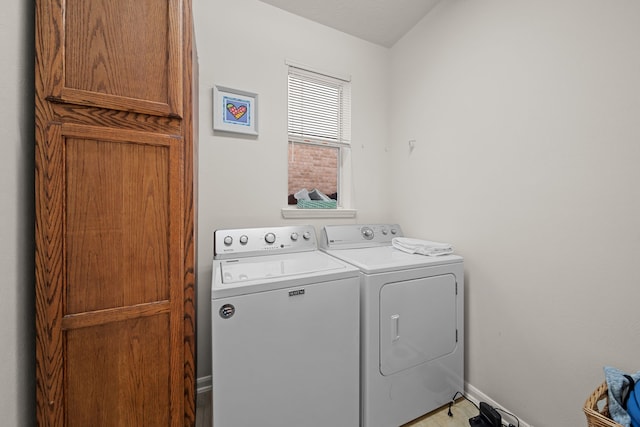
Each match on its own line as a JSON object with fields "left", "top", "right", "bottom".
{"left": 288, "top": 63, "right": 351, "bottom": 207}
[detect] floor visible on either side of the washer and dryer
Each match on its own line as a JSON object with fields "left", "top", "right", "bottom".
{"left": 196, "top": 391, "right": 478, "bottom": 427}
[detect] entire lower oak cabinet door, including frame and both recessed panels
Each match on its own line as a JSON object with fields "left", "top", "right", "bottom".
{"left": 40, "top": 124, "right": 185, "bottom": 426}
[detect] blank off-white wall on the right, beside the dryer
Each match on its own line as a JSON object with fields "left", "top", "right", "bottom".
{"left": 391, "top": 0, "right": 640, "bottom": 426}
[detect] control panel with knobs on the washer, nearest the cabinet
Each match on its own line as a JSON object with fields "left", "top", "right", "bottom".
{"left": 213, "top": 225, "right": 318, "bottom": 259}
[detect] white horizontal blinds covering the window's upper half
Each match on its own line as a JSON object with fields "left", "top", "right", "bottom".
{"left": 288, "top": 65, "right": 351, "bottom": 145}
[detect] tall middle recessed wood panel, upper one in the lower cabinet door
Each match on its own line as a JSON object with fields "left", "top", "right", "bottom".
{"left": 65, "top": 133, "right": 170, "bottom": 313}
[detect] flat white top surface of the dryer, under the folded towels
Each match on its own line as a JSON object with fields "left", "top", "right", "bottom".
{"left": 326, "top": 246, "right": 463, "bottom": 273}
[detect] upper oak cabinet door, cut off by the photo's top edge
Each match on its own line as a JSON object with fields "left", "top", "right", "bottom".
{"left": 49, "top": 0, "right": 183, "bottom": 117}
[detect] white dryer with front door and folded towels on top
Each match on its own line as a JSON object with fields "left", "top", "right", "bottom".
{"left": 320, "top": 224, "right": 464, "bottom": 427}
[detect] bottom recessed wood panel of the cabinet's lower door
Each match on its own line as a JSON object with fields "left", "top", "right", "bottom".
{"left": 65, "top": 314, "right": 170, "bottom": 427}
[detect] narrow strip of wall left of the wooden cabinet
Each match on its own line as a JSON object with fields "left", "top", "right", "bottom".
{"left": 0, "top": 2, "right": 35, "bottom": 426}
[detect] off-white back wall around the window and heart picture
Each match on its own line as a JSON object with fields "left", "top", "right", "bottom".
{"left": 194, "top": 0, "right": 391, "bottom": 378}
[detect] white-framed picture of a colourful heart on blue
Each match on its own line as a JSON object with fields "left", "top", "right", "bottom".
{"left": 213, "top": 85, "right": 258, "bottom": 135}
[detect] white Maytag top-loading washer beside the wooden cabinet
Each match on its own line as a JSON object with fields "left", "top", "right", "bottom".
{"left": 211, "top": 226, "right": 360, "bottom": 427}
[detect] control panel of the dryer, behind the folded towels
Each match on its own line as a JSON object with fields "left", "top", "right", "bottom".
{"left": 320, "top": 224, "right": 403, "bottom": 249}
